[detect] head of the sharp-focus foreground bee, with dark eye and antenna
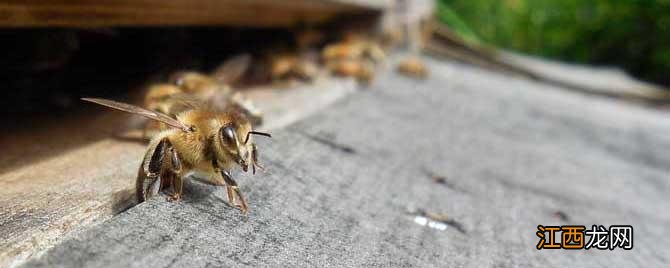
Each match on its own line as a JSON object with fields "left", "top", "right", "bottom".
{"left": 217, "top": 124, "right": 271, "bottom": 172}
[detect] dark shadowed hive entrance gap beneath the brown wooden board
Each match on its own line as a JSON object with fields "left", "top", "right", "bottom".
{"left": 0, "top": 27, "right": 294, "bottom": 116}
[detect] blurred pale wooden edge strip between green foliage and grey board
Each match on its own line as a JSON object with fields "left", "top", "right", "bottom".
{"left": 425, "top": 23, "right": 670, "bottom": 105}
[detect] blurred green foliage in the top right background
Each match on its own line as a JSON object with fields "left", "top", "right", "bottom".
{"left": 438, "top": 0, "right": 670, "bottom": 86}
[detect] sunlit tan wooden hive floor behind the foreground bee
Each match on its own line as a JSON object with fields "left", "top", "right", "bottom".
{"left": 0, "top": 80, "right": 355, "bottom": 267}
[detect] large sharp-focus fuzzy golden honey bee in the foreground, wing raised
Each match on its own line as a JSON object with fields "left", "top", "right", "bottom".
{"left": 82, "top": 98, "right": 271, "bottom": 214}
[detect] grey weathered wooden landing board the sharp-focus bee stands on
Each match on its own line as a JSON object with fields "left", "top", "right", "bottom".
{"left": 21, "top": 55, "right": 670, "bottom": 267}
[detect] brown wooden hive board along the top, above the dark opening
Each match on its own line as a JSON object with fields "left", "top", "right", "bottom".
{"left": 0, "top": 0, "right": 386, "bottom": 27}
